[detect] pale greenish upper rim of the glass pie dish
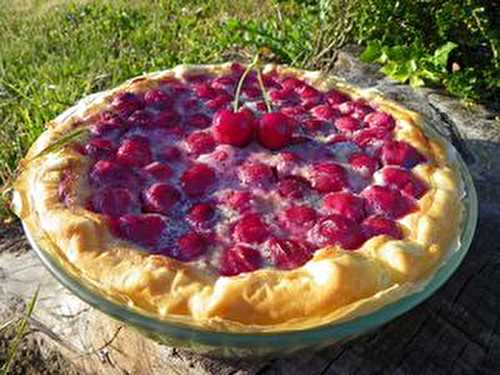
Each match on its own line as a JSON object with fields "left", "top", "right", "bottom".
{"left": 22, "top": 124, "right": 478, "bottom": 346}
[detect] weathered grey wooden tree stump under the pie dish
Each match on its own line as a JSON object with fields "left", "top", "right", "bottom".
{"left": 0, "top": 52, "right": 500, "bottom": 375}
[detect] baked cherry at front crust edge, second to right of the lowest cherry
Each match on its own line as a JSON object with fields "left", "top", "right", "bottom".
{"left": 312, "top": 214, "right": 366, "bottom": 250}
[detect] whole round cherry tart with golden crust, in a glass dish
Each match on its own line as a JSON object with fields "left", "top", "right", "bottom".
{"left": 14, "top": 63, "right": 463, "bottom": 331}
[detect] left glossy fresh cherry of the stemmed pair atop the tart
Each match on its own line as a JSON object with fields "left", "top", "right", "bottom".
{"left": 212, "top": 109, "right": 254, "bottom": 147}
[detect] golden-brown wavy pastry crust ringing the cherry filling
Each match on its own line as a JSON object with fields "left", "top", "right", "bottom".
{"left": 13, "top": 64, "right": 463, "bottom": 332}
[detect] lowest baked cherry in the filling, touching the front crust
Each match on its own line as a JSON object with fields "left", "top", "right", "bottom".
{"left": 219, "top": 245, "right": 262, "bottom": 276}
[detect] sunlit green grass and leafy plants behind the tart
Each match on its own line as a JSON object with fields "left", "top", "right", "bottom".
{"left": 0, "top": 0, "right": 500, "bottom": 218}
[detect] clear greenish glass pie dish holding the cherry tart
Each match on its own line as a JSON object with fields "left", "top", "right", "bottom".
{"left": 24, "top": 117, "right": 478, "bottom": 357}
